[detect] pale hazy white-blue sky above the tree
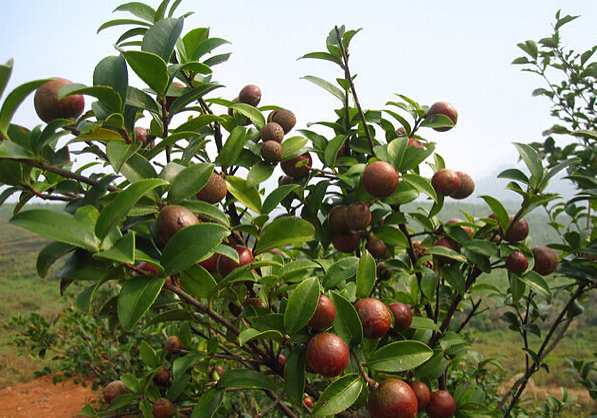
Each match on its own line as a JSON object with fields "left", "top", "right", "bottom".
{"left": 0, "top": 0, "right": 597, "bottom": 189}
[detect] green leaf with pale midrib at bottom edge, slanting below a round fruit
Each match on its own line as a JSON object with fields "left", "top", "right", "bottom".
{"left": 313, "top": 373, "right": 363, "bottom": 417}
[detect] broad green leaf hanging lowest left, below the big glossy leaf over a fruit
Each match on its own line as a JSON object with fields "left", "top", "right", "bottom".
{"left": 117, "top": 276, "right": 166, "bottom": 330}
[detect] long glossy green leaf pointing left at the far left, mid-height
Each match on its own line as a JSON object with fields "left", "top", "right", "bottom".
{"left": 10, "top": 209, "right": 99, "bottom": 252}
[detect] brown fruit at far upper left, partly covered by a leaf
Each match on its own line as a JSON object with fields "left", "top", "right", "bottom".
{"left": 33, "top": 78, "right": 85, "bottom": 123}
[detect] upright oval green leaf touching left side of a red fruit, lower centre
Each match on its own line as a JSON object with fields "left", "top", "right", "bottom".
{"left": 284, "top": 278, "right": 319, "bottom": 334}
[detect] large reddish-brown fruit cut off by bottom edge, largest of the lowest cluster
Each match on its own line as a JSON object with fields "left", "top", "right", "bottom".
{"left": 367, "top": 379, "right": 419, "bottom": 418}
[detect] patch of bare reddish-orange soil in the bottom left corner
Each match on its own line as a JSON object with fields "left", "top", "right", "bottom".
{"left": 0, "top": 376, "right": 98, "bottom": 418}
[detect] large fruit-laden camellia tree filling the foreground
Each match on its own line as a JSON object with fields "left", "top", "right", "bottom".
{"left": 0, "top": 0, "right": 595, "bottom": 418}
